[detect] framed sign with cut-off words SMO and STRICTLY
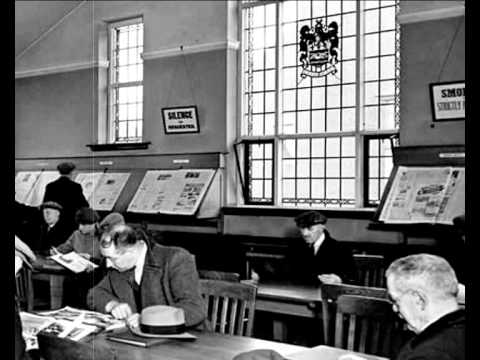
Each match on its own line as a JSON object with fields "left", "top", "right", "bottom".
{"left": 430, "top": 81, "right": 465, "bottom": 121}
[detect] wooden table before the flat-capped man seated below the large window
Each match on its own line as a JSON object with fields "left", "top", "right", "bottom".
{"left": 255, "top": 282, "right": 322, "bottom": 341}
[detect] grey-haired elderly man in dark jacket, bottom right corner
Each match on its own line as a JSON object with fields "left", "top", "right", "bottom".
{"left": 386, "top": 254, "right": 465, "bottom": 360}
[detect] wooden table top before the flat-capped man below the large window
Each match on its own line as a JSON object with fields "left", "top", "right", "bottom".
{"left": 257, "top": 282, "right": 322, "bottom": 303}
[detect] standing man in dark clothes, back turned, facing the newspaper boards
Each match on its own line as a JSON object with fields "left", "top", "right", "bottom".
{"left": 43, "top": 162, "right": 89, "bottom": 233}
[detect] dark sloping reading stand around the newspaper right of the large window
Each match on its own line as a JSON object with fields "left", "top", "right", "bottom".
{"left": 368, "top": 145, "right": 465, "bottom": 245}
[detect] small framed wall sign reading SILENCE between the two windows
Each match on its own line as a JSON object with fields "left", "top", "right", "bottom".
{"left": 162, "top": 106, "right": 200, "bottom": 134}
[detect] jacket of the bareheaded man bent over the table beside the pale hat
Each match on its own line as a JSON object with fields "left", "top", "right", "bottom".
{"left": 87, "top": 243, "right": 206, "bottom": 327}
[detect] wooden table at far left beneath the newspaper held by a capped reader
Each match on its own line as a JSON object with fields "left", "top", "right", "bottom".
{"left": 32, "top": 255, "right": 73, "bottom": 310}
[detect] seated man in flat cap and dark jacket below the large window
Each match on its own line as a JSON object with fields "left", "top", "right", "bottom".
{"left": 291, "top": 211, "right": 357, "bottom": 285}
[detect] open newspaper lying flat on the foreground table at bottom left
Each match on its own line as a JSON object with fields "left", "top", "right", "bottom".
{"left": 20, "top": 306, "right": 125, "bottom": 351}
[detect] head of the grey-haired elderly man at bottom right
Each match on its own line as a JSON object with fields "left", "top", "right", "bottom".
{"left": 385, "top": 254, "right": 458, "bottom": 334}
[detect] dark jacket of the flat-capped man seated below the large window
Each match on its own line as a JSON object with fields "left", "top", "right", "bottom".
{"left": 289, "top": 230, "right": 357, "bottom": 285}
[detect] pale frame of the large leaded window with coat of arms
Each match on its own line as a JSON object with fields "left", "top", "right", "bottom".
{"left": 237, "top": 0, "right": 400, "bottom": 209}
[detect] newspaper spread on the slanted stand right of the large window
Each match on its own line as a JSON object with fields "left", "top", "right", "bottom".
{"left": 379, "top": 166, "right": 465, "bottom": 224}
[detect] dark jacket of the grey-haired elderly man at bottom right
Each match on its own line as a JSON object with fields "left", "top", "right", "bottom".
{"left": 396, "top": 310, "right": 465, "bottom": 360}
